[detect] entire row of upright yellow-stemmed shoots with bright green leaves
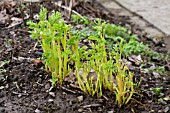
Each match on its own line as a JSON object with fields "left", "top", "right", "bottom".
{"left": 28, "top": 8, "right": 134, "bottom": 107}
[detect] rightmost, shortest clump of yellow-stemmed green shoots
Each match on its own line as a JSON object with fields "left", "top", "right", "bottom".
{"left": 103, "top": 40, "right": 135, "bottom": 107}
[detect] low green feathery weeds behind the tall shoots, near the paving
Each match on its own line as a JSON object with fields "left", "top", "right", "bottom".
{"left": 71, "top": 18, "right": 154, "bottom": 58}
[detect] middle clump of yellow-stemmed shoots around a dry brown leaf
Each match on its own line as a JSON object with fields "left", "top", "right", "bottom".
{"left": 73, "top": 31, "right": 106, "bottom": 97}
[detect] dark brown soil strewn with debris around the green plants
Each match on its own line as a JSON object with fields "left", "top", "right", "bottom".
{"left": 0, "top": 2, "right": 170, "bottom": 113}
